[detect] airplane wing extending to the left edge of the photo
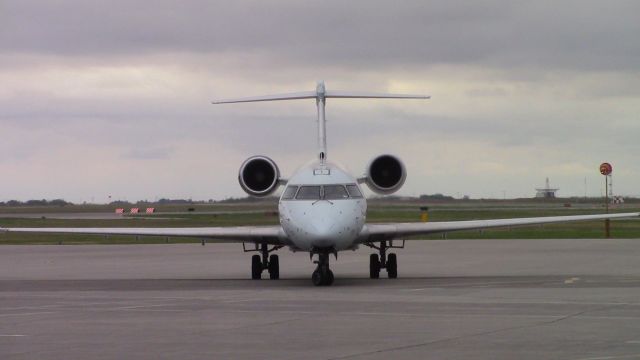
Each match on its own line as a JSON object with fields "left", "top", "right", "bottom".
{"left": 0, "top": 225, "right": 289, "bottom": 245}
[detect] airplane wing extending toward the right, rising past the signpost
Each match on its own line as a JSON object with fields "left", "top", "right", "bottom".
{"left": 358, "top": 213, "right": 640, "bottom": 243}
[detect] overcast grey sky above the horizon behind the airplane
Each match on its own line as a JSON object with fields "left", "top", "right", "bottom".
{"left": 0, "top": 0, "right": 640, "bottom": 202}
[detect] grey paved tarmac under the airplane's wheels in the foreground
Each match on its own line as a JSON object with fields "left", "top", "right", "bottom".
{"left": 0, "top": 240, "right": 640, "bottom": 360}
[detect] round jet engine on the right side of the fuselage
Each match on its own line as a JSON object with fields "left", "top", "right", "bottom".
{"left": 365, "top": 155, "right": 407, "bottom": 195}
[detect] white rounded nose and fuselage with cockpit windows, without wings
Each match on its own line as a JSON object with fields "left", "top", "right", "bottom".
{"left": 278, "top": 161, "right": 367, "bottom": 251}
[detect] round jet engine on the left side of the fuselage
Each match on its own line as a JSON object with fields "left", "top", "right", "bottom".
{"left": 238, "top": 156, "right": 280, "bottom": 197}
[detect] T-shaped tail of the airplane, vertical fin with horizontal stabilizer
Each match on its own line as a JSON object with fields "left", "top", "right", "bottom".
{"left": 211, "top": 81, "right": 431, "bottom": 164}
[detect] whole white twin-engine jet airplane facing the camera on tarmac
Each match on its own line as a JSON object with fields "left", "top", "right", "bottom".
{"left": 0, "top": 81, "right": 640, "bottom": 286}
